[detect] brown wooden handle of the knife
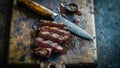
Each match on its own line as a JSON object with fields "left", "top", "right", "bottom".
{"left": 18, "top": 0, "right": 54, "bottom": 17}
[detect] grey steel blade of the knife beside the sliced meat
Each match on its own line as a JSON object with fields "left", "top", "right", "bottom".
{"left": 54, "top": 16, "right": 94, "bottom": 40}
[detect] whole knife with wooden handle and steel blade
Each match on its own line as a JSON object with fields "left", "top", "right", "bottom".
{"left": 18, "top": 0, "right": 94, "bottom": 40}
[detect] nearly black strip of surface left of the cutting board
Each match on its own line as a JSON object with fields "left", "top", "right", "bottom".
{"left": 0, "top": 0, "right": 12, "bottom": 68}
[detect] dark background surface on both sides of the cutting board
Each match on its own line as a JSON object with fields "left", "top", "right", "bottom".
{"left": 0, "top": 0, "right": 120, "bottom": 68}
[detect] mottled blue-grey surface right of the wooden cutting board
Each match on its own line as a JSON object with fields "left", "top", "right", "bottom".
{"left": 95, "top": 0, "right": 120, "bottom": 68}
